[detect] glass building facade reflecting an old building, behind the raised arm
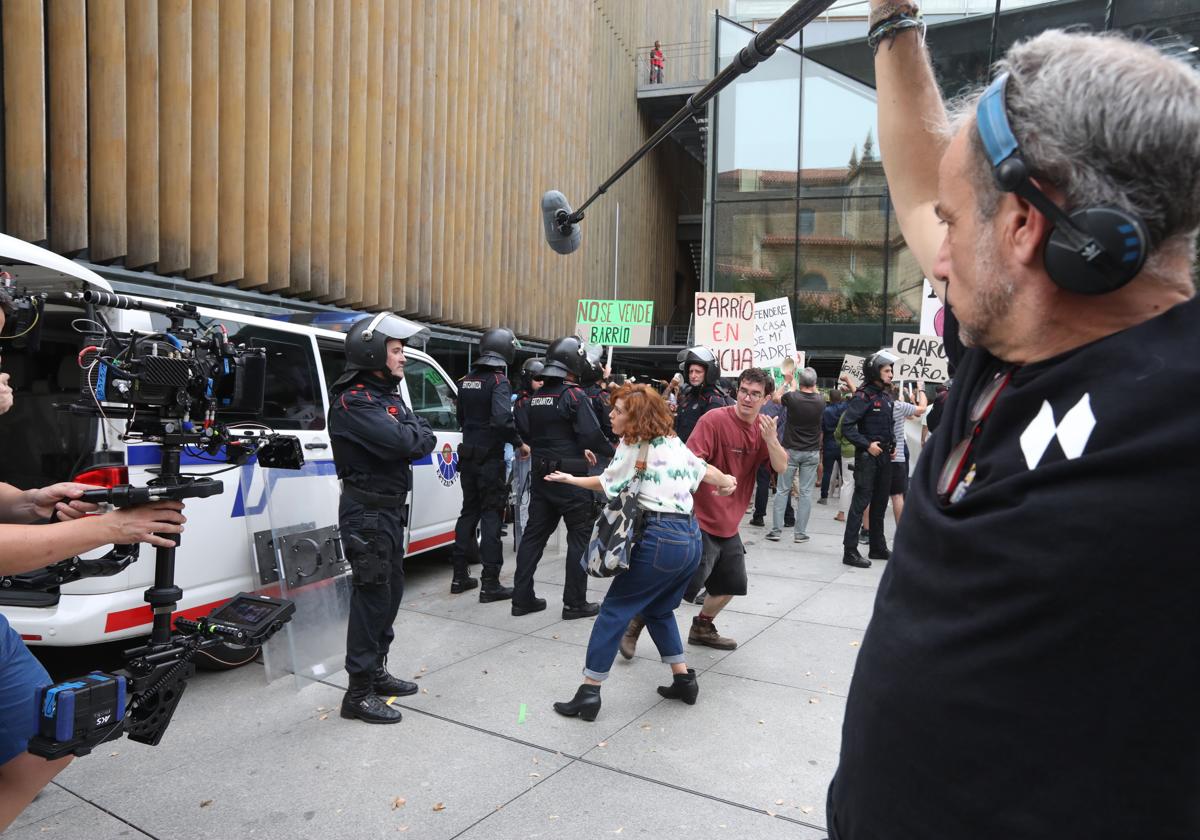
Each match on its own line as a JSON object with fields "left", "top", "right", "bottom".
{"left": 704, "top": 0, "right": 1200, "bottom": 376}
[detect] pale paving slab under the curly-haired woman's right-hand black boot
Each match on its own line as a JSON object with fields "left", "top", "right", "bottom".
{"left": 586, "top": 672, "right": 846, "bottom": 826}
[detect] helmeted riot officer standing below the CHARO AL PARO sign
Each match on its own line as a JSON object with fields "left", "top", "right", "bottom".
{"left": 841, "top": 350, "right": 895, "bottom": 569}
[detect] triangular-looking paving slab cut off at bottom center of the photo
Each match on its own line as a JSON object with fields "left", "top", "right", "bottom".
{"left": 451, "top": 762, "right": 826, "bottom": 840}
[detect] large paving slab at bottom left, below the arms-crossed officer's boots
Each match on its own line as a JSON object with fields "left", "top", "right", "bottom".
{"left": 51, "top": 712, "right": 566, "bottom": 840}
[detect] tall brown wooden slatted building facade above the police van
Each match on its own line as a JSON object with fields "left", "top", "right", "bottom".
{"left": 0, "top": 0, "right": 712, "bottom": 338}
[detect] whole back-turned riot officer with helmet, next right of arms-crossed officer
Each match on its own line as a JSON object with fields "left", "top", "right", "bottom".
{"left": 450, "top": 329, "right": 529, "bottom": 604}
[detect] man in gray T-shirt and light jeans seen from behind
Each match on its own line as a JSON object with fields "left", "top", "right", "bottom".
{"left": 767, "top": 367, "right": 824, "bottom": 542}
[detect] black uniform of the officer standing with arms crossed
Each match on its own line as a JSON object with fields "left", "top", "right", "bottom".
{"left": 329, "top": 372, "right": 437, "bottom": 680}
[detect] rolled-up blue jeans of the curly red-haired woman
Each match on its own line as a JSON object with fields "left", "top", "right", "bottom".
{"left": 583, "top": 512, "right": 701, "bottom": 680}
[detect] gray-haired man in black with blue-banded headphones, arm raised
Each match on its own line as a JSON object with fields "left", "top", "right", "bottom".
{"left": 827, "top": 8, "right": 1200, "bottom": 840}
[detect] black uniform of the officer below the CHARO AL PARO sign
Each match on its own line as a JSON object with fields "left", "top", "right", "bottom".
{"left": 841, "top": 383, "right": 895, "bottom": 556}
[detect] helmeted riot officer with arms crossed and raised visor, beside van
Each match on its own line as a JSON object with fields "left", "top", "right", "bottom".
{"left": 329, "top": 312, "right": 437, "bottom": 724}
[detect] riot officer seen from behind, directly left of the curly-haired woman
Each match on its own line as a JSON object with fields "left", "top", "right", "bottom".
{"left": 512, "top": 336, "right": 613, "bottom": 619}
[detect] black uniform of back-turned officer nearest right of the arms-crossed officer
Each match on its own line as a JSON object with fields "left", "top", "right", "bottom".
{"left": 454, "top": 366, "right": 521, "bottom": 594}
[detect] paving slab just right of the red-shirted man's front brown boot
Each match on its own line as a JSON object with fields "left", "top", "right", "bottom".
{"left": 710, "top": 619, "right": 863, "bottom": 697}
